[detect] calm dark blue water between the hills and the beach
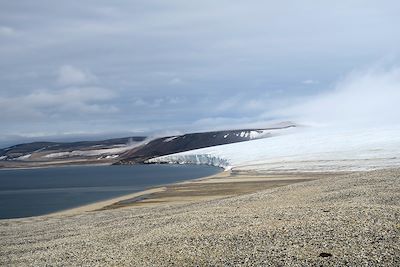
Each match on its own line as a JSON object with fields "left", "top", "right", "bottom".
{"left": 0, "top": 165, "right": 220, "bottom": 219}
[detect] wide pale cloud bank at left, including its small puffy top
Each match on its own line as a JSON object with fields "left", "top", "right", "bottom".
{"left": 0, "top": 65, "right": 119, "bottom": 120}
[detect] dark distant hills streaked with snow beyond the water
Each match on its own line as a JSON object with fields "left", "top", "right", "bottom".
{"left": 0, "top": 124, "right": 295, "bottom": 168}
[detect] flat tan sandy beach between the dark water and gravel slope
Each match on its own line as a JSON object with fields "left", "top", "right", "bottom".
{"left": 55, "top": 170, "right": 338, "bottom": 217}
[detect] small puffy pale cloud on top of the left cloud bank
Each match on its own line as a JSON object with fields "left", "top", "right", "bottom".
{"left": 58, "top": 65, "right": 96, "bottom": 85}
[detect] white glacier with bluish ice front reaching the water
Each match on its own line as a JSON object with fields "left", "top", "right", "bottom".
{"left": 149, "top": 126, "right": 400, "bottom": 171}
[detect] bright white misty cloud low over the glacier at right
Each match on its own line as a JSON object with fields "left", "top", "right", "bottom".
{"left": 275, "top": 67, "right": 400, "bottom": 126}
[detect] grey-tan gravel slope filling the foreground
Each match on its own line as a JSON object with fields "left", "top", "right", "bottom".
{"left": 0, "top": 170, "right": 400, "bottom": 266}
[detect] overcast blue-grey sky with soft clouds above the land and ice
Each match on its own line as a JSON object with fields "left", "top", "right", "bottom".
{"left": 0, "top": 0, "right": 400, "bottom": 146}
